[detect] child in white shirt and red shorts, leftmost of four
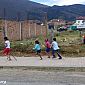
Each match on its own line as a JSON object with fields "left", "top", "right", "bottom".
{"left": 3, "top": 37, "right": 11, "bottom": 60}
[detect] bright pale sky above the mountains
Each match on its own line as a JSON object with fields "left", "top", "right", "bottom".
{"left": 31, "top": 0, "right": 85, "bottom": 6}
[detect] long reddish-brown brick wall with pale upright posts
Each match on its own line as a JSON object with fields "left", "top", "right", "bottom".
{"left": 0, "top": 21, "right": 46, "bottom": 40}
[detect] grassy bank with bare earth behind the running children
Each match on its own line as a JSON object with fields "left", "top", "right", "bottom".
{"left": 0, "top": 31, "right": 85, "bottom": 57}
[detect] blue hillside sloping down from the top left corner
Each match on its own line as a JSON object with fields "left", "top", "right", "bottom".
{"left": 0, "top": 0, "right": 47, "bottom": 20}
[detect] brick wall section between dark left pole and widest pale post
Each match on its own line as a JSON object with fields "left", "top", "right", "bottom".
{"left": 7, "top": 21, "right": 20, "bottom": 40}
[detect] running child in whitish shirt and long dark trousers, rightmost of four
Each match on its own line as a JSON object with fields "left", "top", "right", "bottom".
{"left": 52, "top": 38, "right": 62, "bottom": 59}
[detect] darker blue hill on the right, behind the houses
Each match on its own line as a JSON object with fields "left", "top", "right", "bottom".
{"left": 44, "top": 4, "right": 85, "bottom": 20}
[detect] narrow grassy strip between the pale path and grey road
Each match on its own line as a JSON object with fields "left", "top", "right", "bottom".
{"left": 0, "top": 66, "right": 85, "bottom": 72}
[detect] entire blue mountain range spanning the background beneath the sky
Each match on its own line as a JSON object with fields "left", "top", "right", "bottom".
{"left": 0, "top": 0, "right": 85, "bottom": 20}
